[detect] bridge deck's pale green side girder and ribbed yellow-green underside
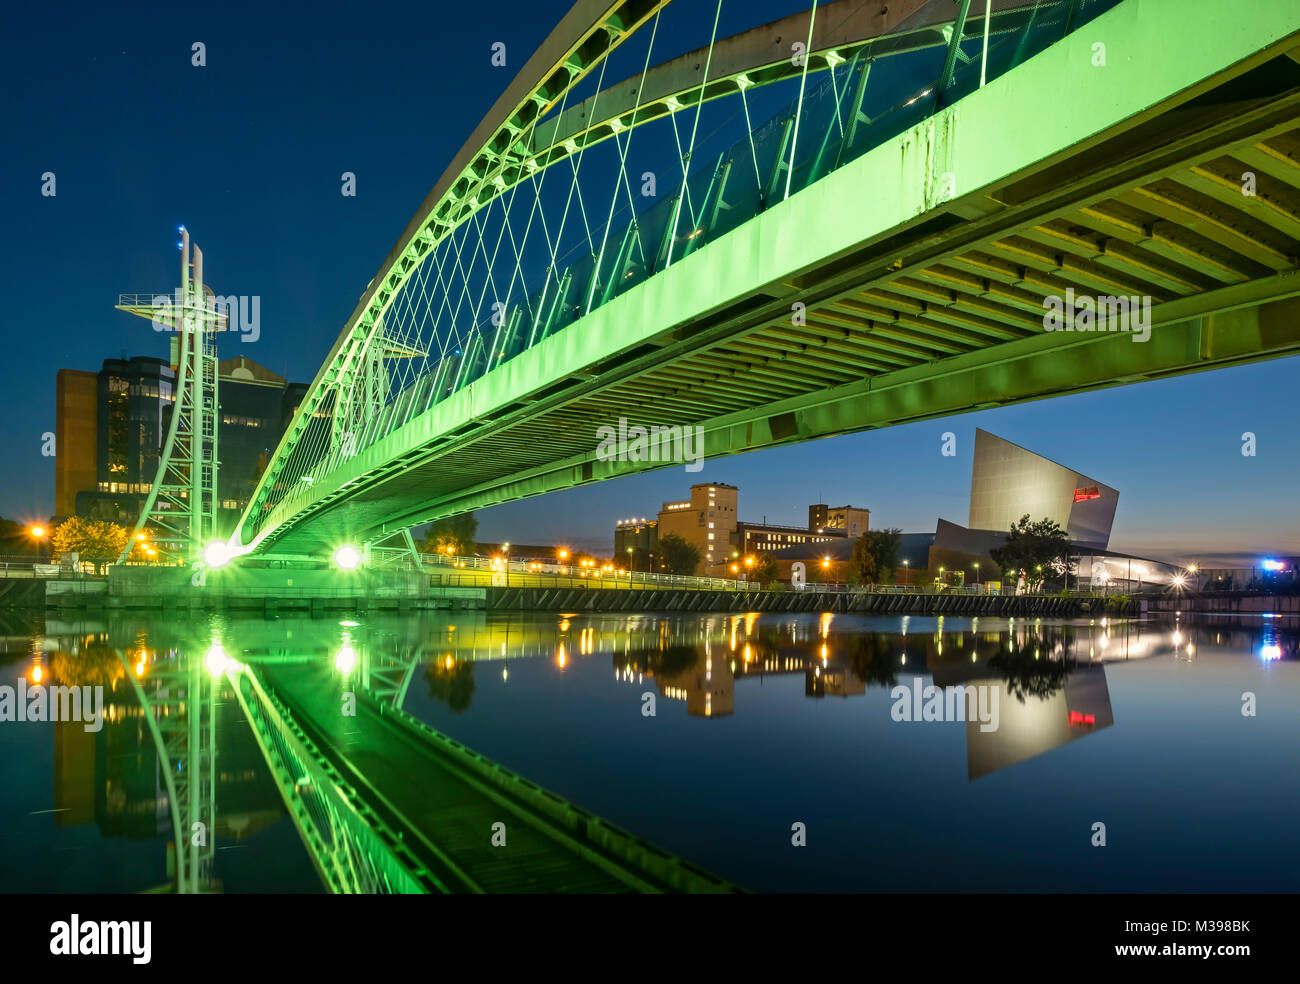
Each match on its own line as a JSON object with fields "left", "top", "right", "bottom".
{"left": 256, "top": 0, "right": 1300, "bottom": 552}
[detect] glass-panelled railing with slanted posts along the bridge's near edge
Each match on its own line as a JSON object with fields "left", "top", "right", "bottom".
{"left": 405, "top": 0, "right": 1121, "bottom": 406}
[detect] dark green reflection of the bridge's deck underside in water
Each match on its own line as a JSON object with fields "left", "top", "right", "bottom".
{"left": 257, "top": 663, "right": 736, "bottom": 893}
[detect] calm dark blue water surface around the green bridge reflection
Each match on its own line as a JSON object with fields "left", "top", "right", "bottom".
{"left": 0, "top": 612, "right": 1300, "bottom": 892}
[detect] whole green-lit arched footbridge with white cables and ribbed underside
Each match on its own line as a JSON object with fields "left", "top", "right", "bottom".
{"left": 234, "top": 0, "right": 1300, "bottom": 554}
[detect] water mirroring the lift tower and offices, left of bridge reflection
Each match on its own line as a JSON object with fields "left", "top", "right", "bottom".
{"left": 0, "top": 616, "right": 315, "bottom": 892}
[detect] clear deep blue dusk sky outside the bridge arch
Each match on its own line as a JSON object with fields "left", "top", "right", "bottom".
{"left": 0, "top": 0, "right": 1300, "bottom": 562}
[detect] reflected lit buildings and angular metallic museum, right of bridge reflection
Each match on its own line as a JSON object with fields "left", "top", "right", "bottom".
{"left": 400, "top": 612, "right": 1297, "bottom": 780}
